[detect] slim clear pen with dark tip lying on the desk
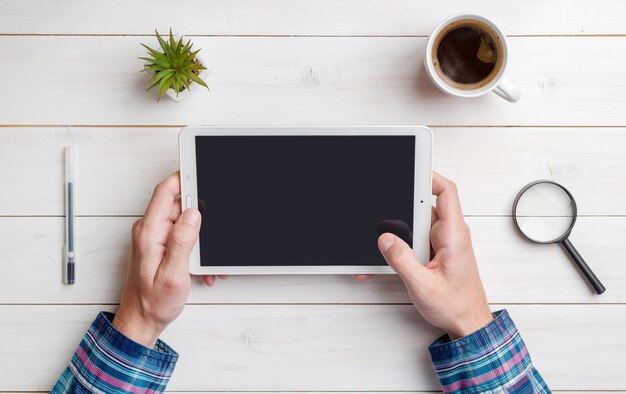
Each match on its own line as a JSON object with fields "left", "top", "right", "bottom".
{"left": 63, "top": 145, "right": 76, "bottom": 285}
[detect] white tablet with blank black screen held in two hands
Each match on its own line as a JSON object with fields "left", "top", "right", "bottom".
{"left": 179, "top": 126, "right": 432, "bottom": 275}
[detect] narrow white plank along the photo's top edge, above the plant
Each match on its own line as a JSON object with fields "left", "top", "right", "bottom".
{"left": 0, "top": 0, "right": 626, "bottom": 36}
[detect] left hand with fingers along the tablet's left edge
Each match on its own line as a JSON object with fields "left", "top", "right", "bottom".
{"left": 113, "top": 173, "right": 201, "bottom": 347}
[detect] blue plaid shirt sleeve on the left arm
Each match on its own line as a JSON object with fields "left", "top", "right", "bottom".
{"left": 52, "top": 312, "right": 178, "bottom": 394}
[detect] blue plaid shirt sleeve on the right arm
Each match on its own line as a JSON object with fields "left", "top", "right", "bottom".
{"left": 429, "top": 310, "right": 550, "bottom": 393}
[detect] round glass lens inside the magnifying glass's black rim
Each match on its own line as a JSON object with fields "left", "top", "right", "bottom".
{"left": 514, "top": 182, "right": 576, "bottom": 243}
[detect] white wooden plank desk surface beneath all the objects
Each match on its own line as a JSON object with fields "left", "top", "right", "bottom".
{"left": 0, "top": 0, "right": 626, "bottom": 392}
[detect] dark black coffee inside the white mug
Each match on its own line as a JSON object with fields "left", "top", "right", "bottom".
{"left": 437, "top": 26, "right": 498, "bottom": 84}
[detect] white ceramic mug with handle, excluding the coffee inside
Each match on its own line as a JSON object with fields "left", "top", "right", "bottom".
{"left": 424, "top": 14, "right": 522, "bottom": 103}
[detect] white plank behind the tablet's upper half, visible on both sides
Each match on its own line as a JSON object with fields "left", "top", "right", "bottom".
{"left": 0, "top": 127, "right": 626, "bottom": 216}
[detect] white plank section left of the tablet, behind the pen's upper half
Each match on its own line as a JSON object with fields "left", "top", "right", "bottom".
{"left": 0, "top": 127, "right": 179, "bottom": 215}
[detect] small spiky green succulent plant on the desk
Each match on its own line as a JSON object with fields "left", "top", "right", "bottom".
{"left": 139, "top": 29, "right": 209, "bottom": 101}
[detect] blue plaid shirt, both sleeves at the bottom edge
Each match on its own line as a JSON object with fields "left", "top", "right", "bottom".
{"left": 52, "top": 311, "right": 550, "bottom": 394}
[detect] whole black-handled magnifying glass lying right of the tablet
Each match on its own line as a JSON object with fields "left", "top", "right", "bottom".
{"left": 513, "top": 180, "right": 606, "bottom": 294}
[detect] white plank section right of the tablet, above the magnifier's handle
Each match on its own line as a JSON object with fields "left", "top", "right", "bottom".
{"left": 434, "top": 128, "right": 626, "bottom": 215}
